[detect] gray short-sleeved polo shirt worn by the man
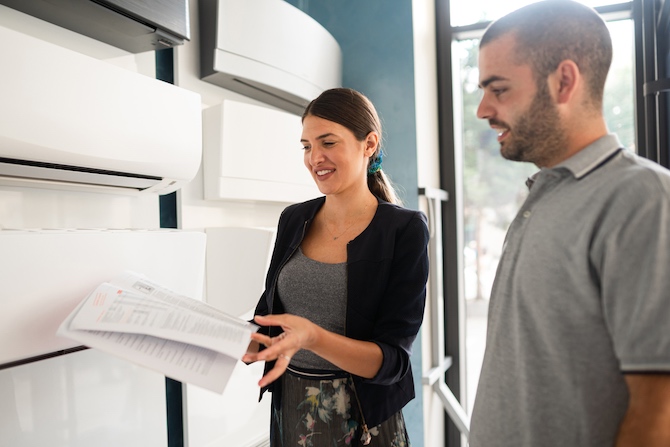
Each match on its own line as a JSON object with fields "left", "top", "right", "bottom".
{"left": 470, "top": 135, "right": 670, "bottom": 447}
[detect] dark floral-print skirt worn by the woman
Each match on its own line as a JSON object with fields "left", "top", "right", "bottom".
{"left": 270, "top": 367, "right": 411, "bottom": 447}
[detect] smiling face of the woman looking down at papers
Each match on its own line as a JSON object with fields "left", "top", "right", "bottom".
{"left": 300, "top": 115, "right": 379, "bottom": 195}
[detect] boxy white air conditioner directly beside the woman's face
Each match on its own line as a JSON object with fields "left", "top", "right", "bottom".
{"left": 202, "top": 99, "right": 321, "bottom": 203}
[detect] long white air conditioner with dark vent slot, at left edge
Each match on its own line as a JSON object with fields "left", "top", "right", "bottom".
{"left": 0, "top": 27, "right": 202, "bottom": 194}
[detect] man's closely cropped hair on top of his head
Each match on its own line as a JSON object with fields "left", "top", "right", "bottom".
{"left": 479, "top": 0, "right": 612, "bottom": 109}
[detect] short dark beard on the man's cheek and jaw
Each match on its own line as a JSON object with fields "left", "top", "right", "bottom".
{"left": 500, "top": 83, "right": 567, "bottom": 167}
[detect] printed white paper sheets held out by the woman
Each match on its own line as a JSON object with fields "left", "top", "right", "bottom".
{"left": 58, "top": 272, "right": 258, "bottom": 393}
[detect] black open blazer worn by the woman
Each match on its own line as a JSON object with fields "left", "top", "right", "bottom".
{"left": 255, "top": 197, "right": 430, "bottom": 428}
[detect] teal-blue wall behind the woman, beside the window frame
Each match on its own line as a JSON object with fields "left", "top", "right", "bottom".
{"left": 286, "top": 0, "right": 424, "bottom": 447}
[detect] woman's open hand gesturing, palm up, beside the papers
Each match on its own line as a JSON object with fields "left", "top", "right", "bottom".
{"left": 242, "top": 314, "right": 319, "bottom": 387}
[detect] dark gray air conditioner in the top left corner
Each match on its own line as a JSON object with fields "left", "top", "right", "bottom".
{"left": 0, "top": 0, "right": 191, "bottom": 53}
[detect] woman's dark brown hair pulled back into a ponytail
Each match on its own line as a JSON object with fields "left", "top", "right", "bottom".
{"left": 302, "top": 88, "right": 400, "bottom": 204}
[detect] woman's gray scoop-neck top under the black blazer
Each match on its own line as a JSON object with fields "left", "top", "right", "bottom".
{"left": 277, "top": 248, "right": 347, "bottom": 370}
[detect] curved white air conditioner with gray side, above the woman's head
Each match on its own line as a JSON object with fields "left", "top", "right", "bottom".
{"left": 199, "top": 0, "right": 342, "bottom": 114}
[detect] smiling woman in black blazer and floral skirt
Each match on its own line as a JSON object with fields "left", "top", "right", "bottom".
{"left": 243, "top": 88, "right": 429, "bottom": 447}
